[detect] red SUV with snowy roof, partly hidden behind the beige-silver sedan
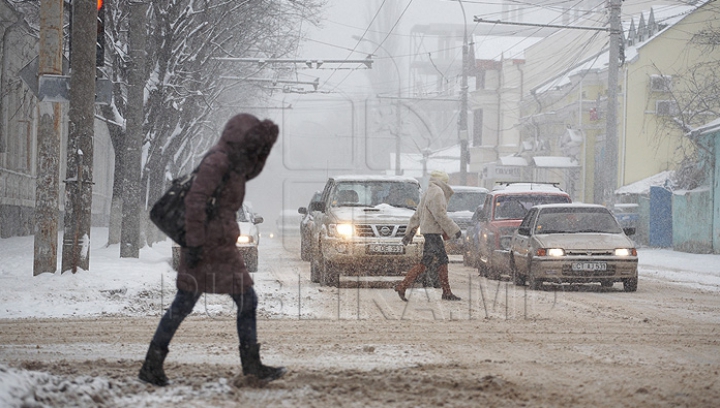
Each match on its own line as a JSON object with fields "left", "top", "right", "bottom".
{"left": 468, "top": 183, "right": 572, "bottom": 279}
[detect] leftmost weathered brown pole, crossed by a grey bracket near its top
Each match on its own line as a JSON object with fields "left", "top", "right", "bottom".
{"left": 33, "top": 0, "right": 63, "bottom": 276}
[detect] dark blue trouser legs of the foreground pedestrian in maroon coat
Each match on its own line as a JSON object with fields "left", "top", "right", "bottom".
{"left": 152, "top": 286, "right": 257, "bottom": 350}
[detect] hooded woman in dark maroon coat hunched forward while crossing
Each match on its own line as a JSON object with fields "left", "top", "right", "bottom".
{"left": 139, "top": 114, "right": 286, "bottom": 386}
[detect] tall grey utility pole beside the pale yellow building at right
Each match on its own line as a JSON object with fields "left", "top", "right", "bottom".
{"left": 596, "top": 0, "right": 622, "bottom": 205}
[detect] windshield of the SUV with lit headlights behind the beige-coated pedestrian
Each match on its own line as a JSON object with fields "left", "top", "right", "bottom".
{"left": 332, "top": 181, "right": 420, "bottom": 210}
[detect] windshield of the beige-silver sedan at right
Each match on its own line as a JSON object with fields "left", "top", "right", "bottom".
{"left": 535, "top": 208, "right": 622, "bottom": 234}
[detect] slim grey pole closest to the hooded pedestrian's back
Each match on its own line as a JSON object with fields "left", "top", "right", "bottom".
{"left": 120, "top": 2, "right": 147, "bottom": 258}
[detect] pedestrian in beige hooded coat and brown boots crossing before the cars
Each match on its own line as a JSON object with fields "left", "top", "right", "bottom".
{"left": 395, "top": 170, "right": 461, "bottom": 302}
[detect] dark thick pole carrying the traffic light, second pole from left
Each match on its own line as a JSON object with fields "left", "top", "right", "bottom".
{"left": 62, "top": 0, "right": 97, "bottom": 273}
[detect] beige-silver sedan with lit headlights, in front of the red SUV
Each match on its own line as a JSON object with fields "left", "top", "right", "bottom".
{"left": 510, "top": 204, "right": 638, "bottom": 292}
